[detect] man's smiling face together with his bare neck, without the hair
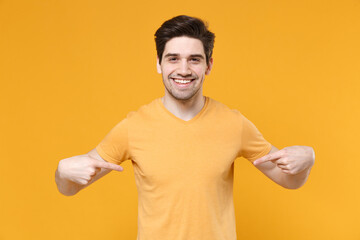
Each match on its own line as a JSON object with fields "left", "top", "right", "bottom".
{"left": 157, "top": 36, "right": 213, "bottom": 120}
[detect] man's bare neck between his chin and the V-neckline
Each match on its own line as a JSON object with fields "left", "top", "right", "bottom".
{"left": 161, "top": 93, "right": 205, "bottom": 121}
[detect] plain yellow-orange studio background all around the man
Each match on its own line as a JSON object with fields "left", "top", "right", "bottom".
{"left": 0, "top": 0, "right": 360, "bottom": 240}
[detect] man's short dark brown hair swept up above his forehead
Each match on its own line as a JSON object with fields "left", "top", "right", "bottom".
{"left": 155, "top": 15, "right": 215, "bottom": 64}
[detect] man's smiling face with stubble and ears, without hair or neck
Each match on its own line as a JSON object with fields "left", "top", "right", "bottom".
{"left": 157, "top": 37, "right": 213, "bottom": 100}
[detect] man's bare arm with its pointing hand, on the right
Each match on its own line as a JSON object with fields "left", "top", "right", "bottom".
{"left": 254, "top": 146, "right": 315, "bottom": 189}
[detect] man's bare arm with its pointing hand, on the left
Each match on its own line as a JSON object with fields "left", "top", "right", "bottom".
{"left": 55, "top": 148, "right": 123, "bottom": 196}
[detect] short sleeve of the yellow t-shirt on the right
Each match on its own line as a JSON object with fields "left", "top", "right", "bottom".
{"left": 240, "top": 115, "right": 272, "bottom": 162}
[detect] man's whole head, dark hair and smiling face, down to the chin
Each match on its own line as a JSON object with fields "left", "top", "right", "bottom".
{"left": 155, "top": 16, "right": 215, "bottom": 101}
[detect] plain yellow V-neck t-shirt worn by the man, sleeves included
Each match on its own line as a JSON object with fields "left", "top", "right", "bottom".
{"left": 96, "top": 97, "right": 271, "bottom": 240}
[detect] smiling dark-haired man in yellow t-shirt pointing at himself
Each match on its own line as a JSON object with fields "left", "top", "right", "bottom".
{"left": 56, "top": 16, "right": 315, "bottom": 240}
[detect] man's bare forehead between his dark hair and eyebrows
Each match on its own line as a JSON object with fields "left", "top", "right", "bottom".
{"left": 163, "top": 37, "right": 205, "bottom": 57}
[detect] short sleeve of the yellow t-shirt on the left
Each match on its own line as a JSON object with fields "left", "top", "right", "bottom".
{"left": 96, "top": 119, "right": 130, "bottom": 164}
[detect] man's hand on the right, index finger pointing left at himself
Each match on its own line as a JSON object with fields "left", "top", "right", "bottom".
{"left": 254, "top": 146, "right": 315, "bottom": 175}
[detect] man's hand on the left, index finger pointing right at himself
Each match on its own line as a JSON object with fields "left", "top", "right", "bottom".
{"left": 58, "top": 155, "right": 123, "bottom": 185}
